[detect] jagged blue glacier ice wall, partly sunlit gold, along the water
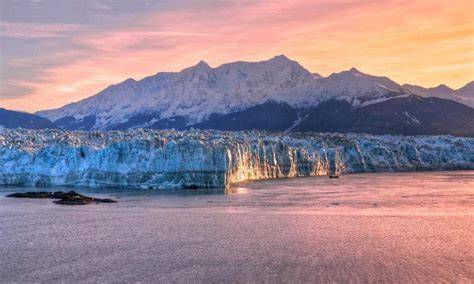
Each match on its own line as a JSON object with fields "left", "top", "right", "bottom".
{"left": 0, "top": 129, "right": 474, "bottom": 188}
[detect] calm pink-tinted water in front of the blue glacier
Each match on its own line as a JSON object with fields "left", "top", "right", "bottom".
{"left": 0, "top": 171, "right": 474, "bottom": 283}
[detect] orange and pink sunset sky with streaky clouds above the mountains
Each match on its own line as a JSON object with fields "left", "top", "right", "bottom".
{"left": 0, "top": 0, "right": 474, "bottom": 112}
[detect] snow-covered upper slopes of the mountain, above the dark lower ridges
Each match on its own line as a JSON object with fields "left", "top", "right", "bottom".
{"left": 37, "top": 55, "right": 412, "bottom": 129}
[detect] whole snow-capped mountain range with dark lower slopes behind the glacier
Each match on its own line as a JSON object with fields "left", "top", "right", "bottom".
{"left": 1, "top": 55, "right": 474, "bottom": 136}
